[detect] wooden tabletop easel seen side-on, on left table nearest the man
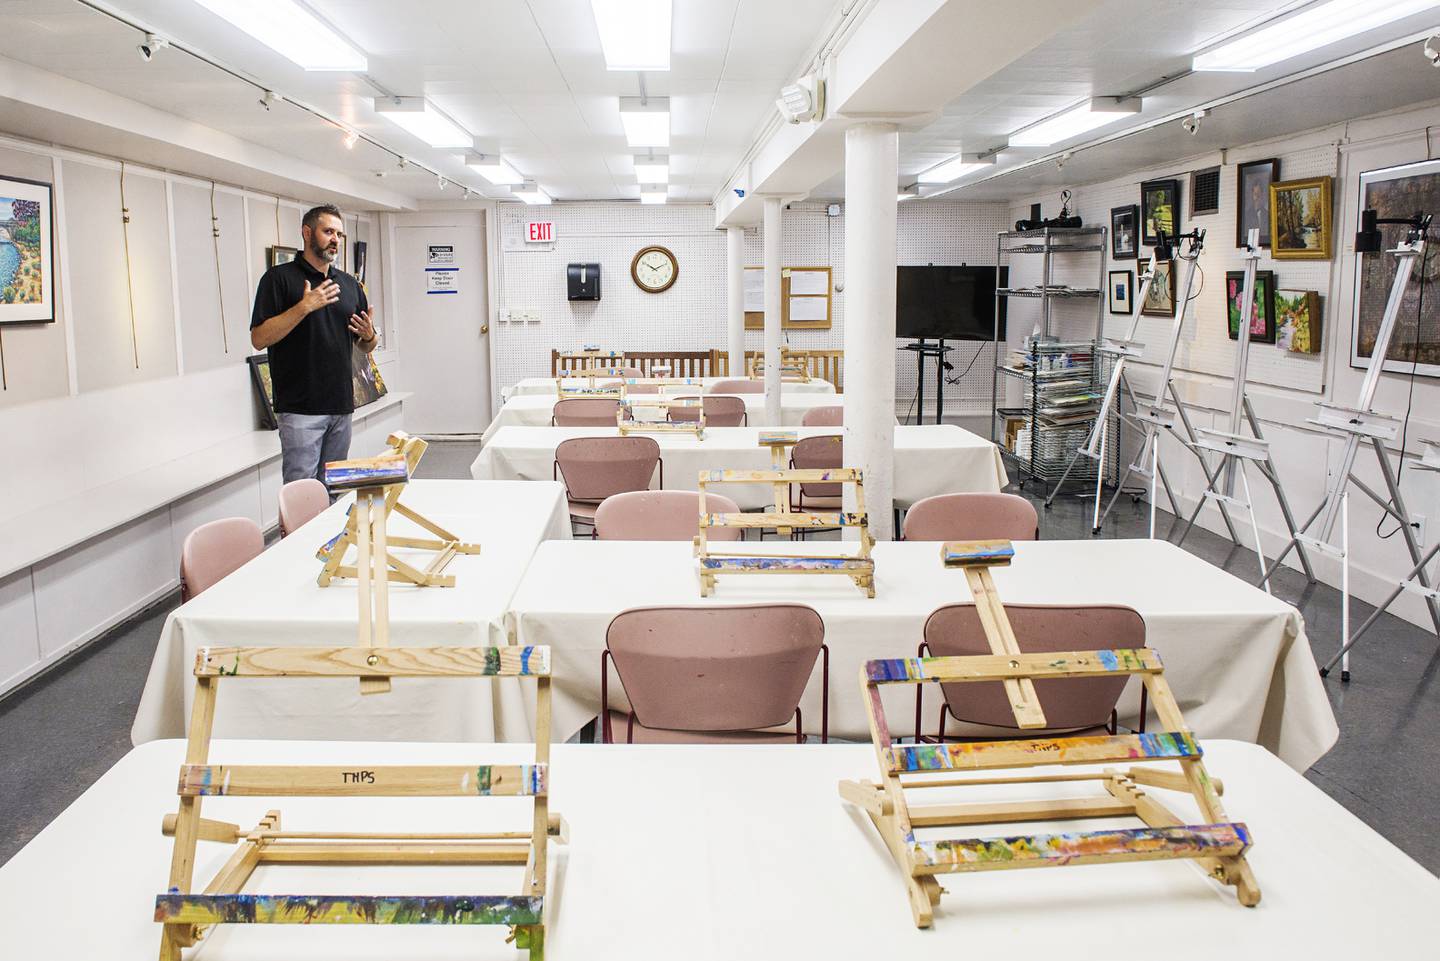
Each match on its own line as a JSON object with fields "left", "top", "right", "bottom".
{"left": 315, "top": 431, "right": 480, "bottom": 590}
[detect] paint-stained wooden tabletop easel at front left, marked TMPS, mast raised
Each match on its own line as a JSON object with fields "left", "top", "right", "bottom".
{"left": 154, "top": 458, "right": 567, "bottom": 961}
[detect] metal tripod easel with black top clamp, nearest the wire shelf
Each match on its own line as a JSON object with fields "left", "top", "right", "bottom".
{"left": 1094, "top": 229, "right": 1240, "bottom": 543}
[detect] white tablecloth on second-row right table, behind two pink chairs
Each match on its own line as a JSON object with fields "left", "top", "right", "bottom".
{"left": 504, "top": 540, "right": 1339, "bottom": 771}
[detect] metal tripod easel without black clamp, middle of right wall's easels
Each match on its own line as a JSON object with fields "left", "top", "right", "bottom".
{"left": 1175, "top": 228, "right": 1315, "bottom": 594}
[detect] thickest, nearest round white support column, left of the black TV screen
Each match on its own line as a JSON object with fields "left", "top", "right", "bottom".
{"left": 844, "top": 122, "right": 900, "bottom": 540}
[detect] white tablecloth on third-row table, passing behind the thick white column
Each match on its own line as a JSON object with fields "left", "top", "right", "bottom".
{"left": 469, "top": 424, "right": 1008, "bottom": 509}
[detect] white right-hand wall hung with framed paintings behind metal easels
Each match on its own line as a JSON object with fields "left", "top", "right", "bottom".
{"left": 1011, "top": 107, "right": 1440, "bottom": 627}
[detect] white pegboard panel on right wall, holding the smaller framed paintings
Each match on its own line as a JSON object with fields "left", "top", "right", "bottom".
{"left": 1009, "top": 144, "right": 1330, "bottom": 393}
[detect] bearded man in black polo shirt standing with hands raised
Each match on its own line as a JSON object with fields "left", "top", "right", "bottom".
{"left": 251, "top": 205, "right": 376, "bottom": 484}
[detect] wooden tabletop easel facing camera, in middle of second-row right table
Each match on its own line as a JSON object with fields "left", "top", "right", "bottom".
{"left": 696, "top": 467, "right": 876, "bottom": 598}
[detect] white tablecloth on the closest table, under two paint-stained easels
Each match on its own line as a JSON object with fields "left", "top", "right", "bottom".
{"left": 0, "top": 741, "right": 1440, "bottom": 961}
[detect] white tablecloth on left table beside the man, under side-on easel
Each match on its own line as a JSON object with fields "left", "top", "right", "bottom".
{"left": 131, "top": 480, "right": 570, "bottom": 743}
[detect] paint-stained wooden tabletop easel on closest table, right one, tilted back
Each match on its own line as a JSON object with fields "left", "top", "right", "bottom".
{"left": 840, "top": 540, "right": 1260, "bottom": 928}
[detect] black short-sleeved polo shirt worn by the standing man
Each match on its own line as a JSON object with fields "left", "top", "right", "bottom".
{"left": 251, "top": 256, "right": 370, "bottom": 414}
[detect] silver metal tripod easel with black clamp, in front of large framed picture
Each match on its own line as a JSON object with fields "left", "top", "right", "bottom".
{"left": 1307, "top": 210, "right": 1440, "bottom": 681}
